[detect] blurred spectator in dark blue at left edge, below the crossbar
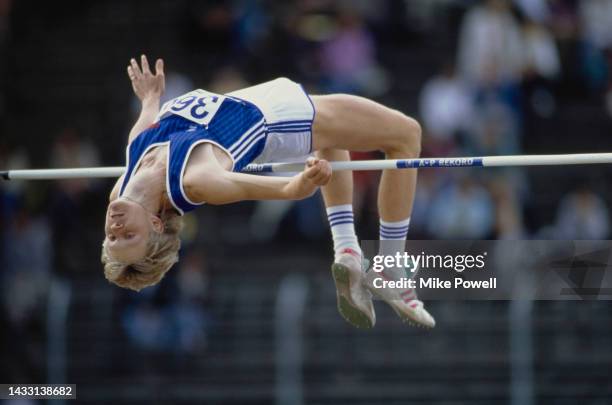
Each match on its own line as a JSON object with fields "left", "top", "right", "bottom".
{"left": 0, "top": 200, "right": 53, "bottom": 381}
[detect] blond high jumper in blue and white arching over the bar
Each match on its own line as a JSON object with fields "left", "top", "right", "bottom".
{"left": 102, "top": 55, "right": 435, "bottom": 328}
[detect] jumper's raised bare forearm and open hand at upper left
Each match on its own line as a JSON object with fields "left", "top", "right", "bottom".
{"left": 127, "top": 55, "right": 166, "bottom": 144}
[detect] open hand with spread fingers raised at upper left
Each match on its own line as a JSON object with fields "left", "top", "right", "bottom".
{"left": 127, "top": 55, "right": 166, "bottom": 102}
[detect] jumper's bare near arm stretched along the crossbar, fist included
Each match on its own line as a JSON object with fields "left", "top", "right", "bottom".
{"left": 190, "top": 158, "right": 332, "bottom": 205}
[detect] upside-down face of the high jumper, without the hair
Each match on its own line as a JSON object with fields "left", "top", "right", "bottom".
{"left": 104, "top": 199, "right": 154, "bottom": 264}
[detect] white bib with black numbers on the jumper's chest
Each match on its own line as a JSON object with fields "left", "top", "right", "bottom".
{"left": 159, "top": 90, "right": 226, "bottom": 125}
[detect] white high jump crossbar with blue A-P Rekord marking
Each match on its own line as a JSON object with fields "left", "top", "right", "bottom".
{"left": 0, "top": 153, "right": 612, "bottom": 180}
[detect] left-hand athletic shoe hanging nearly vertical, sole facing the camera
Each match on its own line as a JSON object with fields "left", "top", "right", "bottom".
{"left": 332, "top": 248, "right": 376, "bottom": 329}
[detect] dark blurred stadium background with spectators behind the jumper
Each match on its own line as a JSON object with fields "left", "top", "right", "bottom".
{"left": 0, "top": 0, "right": 612, "bottom": 405}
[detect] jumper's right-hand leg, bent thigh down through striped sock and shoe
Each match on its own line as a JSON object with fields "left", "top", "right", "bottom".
{"left": 313, "top": 95, "right": 435, "bottom": 327}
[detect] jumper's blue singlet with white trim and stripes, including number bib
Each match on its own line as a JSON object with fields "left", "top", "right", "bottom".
{"left": 119, "top": 90, "right": 267, "bottom": 215}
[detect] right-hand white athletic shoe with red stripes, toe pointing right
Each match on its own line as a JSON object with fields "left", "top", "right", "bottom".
{"left": 364, "top": 262, "right": 436, "bottom": 328}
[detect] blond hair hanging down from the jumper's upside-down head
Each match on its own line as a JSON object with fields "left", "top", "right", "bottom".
{"left": 102, "top": 211, "right": 183, "bottom": 291}
